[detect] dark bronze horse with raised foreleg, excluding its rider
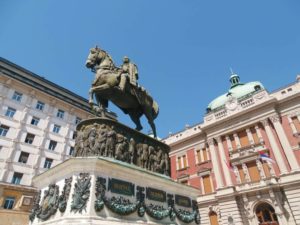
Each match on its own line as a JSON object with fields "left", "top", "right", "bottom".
{"left": 86, "top": 47, "right": 159, "bottom": 138}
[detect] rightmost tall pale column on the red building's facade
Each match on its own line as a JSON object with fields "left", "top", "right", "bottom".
{"left": 270, "top": 115, "right": 299, "bottom": 171}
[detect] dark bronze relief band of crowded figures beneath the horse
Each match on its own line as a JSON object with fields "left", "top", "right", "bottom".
{"left": 74, "top": 118, "right": 170, "bottom": 176}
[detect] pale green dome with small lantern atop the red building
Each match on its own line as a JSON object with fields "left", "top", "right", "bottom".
{"left": 207, "top": 74, "right": 265, "bottom": 112}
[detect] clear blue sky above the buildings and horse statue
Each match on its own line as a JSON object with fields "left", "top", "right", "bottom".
{"left": 0, "top": 0, "right": 300, "bottom": 137}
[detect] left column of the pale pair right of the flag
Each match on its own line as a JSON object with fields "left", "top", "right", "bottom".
{"left": 261, "top": 119, "right": 287, "bottom": 173}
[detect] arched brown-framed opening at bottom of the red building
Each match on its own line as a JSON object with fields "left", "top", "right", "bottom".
{"left": 256, "top": 203, "right": 279, "bottom": 225}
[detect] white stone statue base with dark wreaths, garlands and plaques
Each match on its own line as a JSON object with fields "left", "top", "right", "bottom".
{"left": 30, "top": 157, "right": 199, "bottom": 225}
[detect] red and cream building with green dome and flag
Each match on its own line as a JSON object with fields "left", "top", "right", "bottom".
{"left": 164, "top": 74, "right": 300, "bottom": 225}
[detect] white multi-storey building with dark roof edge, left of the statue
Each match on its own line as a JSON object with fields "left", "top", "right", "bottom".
{"left": 0, "top": 58, "right": 101, "bottom": 225}
